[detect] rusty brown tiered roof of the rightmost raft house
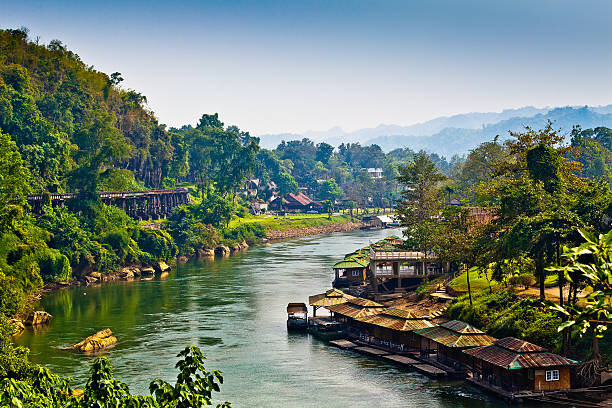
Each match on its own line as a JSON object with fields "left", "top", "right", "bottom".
{"left": 463, "top": 337, "right": 576, "bottom": 370}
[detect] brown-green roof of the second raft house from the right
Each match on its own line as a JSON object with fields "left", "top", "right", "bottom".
{"left": 415, "top": 320, "right": 496, "bottom": 348}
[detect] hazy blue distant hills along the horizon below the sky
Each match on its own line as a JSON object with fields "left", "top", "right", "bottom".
{"left": 259, "top": 105, "right": 612, "bottom": 157}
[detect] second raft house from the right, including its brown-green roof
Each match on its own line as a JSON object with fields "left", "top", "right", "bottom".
{"left": 414, "top": 320, "right": 495, "bottom": 369}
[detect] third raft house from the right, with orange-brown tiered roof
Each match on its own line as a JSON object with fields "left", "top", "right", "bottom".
{"left": 355, "top": 307, "right": 433, "bottom": 351}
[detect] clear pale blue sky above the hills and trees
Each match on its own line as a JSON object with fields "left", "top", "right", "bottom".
{"left": 0, "top": 0, "right": 612, "bottom": 135}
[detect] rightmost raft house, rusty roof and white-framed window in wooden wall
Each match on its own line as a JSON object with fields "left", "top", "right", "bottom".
{"left": 463, "top": 337, "right": 576, "bottom": 392}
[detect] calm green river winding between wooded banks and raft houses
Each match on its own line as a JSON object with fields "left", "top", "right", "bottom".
{"left": 17, "top": 230, "right": 505, "bottom": 408}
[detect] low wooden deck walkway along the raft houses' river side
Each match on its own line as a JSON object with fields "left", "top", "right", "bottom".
{"left": 329, "top": 339, "right": 450, "bottom": 378}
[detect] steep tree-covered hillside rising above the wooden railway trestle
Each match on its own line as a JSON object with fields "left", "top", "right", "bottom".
{"left": 0, "top": 29, "right": 180, "bottom": 192}
